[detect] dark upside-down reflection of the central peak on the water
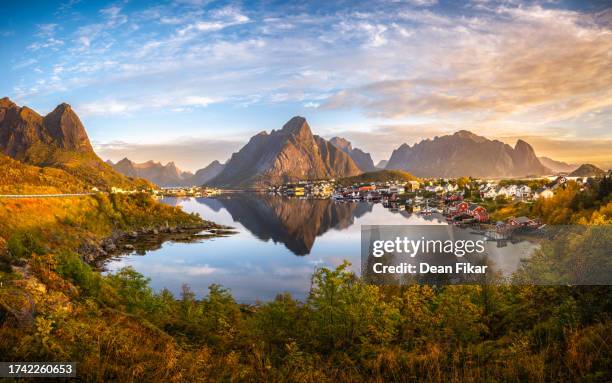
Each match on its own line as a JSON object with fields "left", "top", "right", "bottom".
{"left": 196, "top": 193, "right": 373, "bottom": 255}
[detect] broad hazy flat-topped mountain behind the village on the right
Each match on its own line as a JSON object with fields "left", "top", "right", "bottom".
{"left": 386, "top": 130, "right": 551, "bottom": 177}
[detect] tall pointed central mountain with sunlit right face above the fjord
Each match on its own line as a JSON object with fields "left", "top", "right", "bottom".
{"left": 210, "top": 117, "right": 361, "bottom": 187}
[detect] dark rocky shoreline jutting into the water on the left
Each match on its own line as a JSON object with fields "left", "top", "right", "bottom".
{"left": 77, "top": 222, "right": 235, "bottom": 269}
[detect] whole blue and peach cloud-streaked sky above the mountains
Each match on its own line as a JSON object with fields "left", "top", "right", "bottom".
{"left": 0, "top": 0, "right": 612, "bottom": 170}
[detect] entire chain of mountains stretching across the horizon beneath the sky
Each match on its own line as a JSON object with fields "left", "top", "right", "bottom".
{"left": 0, "top": 98, "right": 603, "bottom": 188}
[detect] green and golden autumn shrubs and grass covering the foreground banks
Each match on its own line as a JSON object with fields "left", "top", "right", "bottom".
{"left": 0, "top": 181, "right": 612, "bottom": 382}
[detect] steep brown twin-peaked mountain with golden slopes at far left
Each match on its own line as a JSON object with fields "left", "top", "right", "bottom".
{"left": 0, "top": 97, "right": 150, "bottom": 189}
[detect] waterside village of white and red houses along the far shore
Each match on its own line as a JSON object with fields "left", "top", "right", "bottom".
{"left": 267, "top": 175, "right": 600, "bottom": 239}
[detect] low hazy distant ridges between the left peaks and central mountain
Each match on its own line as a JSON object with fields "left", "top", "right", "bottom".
{"left": 107, "top": 158, "right": 223, "bottom": 187}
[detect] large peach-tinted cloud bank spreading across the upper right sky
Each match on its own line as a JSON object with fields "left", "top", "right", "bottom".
{"left": 323, "top": 7, "right": 612, "bottom": 122}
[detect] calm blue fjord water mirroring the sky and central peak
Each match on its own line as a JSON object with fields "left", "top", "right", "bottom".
{"left": 106, "top": 193, "right": 536, "bottom": 303}
